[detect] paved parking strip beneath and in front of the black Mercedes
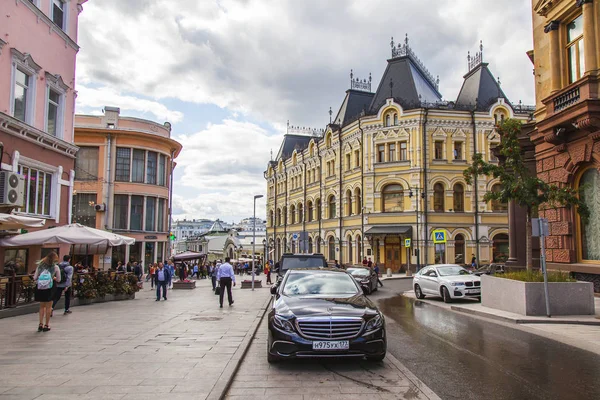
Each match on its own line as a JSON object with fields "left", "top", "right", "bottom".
{"left": 226, "top": 315, "right": 438, "bottom": 400}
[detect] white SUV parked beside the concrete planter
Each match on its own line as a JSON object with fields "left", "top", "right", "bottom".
{"left": 413, "top": 264, "right": 481, "bottom": 303}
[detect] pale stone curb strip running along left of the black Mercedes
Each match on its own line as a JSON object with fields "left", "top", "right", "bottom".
{"left": 206, "top": 290, "right": 273, "bottom": 400}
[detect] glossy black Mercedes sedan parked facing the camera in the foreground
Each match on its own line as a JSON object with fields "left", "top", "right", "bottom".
{"left": 267, "top": 268, "right": 387, "bottom": 363}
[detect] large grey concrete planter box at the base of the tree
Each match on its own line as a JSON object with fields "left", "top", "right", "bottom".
{"left": 481, "top": 275, "right": 595, "bottom": 316}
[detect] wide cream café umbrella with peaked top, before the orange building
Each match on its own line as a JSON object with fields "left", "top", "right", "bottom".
{"left": 0, "top": 224, "right": 135, "bottom": 247}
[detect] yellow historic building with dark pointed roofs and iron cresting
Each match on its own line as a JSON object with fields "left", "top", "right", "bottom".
{"left": 265, "top": 38, "right": 533, "bottom": 271}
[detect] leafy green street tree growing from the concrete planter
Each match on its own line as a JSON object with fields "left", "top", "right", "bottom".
{"left": 463, "top": 119, "right": 589, "bottom": 270}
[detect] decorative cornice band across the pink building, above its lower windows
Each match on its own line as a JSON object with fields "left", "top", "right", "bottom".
{"left": 0, "top": 112, "right": 79, "bottom": 158}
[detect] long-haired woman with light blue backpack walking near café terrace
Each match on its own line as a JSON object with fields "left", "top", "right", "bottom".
{"left": 33, "top": 252, "right": 60, "bottom": 332}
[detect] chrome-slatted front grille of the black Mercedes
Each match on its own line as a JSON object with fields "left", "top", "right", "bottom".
{"left": 297, "top": 317, "right": 363, "bottom": 340}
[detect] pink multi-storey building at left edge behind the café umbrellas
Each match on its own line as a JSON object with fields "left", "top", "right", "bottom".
{"left": 0, "top": 0, "right": 87, "bottom": 273}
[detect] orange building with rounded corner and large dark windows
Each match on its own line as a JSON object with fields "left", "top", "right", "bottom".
{"left": 73, "top": 107, "right": 182, "bottom": 268}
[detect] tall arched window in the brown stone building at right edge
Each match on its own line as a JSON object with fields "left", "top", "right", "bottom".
{"left": 579, "top": 168, "right": 600, "bottom": 261}
